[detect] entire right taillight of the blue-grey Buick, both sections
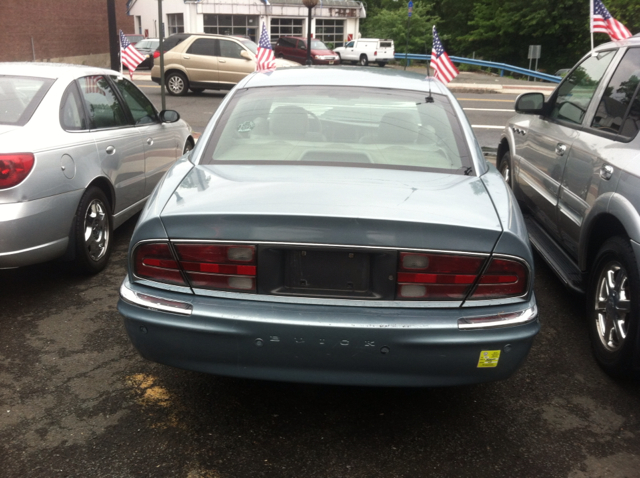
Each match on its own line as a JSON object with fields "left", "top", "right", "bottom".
{"left": 396, "top": 252, "right": 529, "bottom": 300}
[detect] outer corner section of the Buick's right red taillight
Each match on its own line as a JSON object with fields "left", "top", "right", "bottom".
{"left": 469, "top": 259, "right": 529, "bottom": 299}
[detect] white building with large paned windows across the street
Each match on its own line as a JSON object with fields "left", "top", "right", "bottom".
{"left": 128, "top": 0, "right": 366, "bottom": 48}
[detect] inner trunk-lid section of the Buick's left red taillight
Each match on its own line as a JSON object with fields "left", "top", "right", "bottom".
{"left": 175, "top": 244, "right": 256, "bottom": 292}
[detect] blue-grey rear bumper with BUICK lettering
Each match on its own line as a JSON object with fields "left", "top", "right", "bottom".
{"left": 118, "top": 279, "right": 540, "bottom": 386}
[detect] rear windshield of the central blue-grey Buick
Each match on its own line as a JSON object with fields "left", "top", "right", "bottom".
{"left": 201, "top": 86, "right": 472, "bottom": 174}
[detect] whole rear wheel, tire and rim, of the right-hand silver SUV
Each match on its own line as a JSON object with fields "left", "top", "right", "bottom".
{"left": 587, "top": 237, "right": 640, "bottom": 377}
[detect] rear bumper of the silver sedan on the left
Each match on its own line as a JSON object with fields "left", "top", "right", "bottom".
{"left": 0, "top": 190, "right": 83, "bottom": 269}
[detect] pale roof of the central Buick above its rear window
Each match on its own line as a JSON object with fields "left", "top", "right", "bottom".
{"left": 238, "top": 66, "right": 451, "bottom": 96}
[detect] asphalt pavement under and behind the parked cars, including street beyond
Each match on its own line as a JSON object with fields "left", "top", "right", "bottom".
{"left": 0, "top": 83, "right": 640, "bottom": 478}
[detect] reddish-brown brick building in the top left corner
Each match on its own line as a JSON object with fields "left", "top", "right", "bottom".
{"left": 0, "top": 0, "right": 134, "bottom": 67}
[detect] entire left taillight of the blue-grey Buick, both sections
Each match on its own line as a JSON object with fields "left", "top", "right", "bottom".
{"left": 134, "top": 243, "right": 256, "bottom": 292}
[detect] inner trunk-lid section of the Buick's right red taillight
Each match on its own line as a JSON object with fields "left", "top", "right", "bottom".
{"left": 397, "top": 252, "right": 484, "bottom": 300}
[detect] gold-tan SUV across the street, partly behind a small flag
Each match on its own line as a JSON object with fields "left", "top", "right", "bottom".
{"left": 151, "top": 33, "right": 300, "bottom": 96}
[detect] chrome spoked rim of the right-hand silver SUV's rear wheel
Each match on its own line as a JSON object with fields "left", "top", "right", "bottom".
{"left": 594, "top": 261, "right": 631, "bottom": 352}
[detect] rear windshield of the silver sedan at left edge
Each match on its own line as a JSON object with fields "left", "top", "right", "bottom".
{"left": 0, "top": 75, "right": 54, "bottom": 126}
